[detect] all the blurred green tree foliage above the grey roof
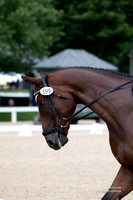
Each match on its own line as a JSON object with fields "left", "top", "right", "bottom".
{"left": 0, "top": 0, "right": 133, "bottom": 73}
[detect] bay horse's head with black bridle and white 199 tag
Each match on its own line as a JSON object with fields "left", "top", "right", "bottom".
{"left": 22, "top": 75, "right": 76, "bottom": 150}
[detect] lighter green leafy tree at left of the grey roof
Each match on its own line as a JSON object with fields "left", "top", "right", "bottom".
{"left": 0, "top": 0, "right": 63, "bottom": 71}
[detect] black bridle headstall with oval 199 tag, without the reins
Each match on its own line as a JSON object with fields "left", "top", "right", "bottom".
{"left": 34, "top": 74, "right": 74, "bottom": 136}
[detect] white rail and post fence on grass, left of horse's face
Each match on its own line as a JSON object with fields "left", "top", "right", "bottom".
{"left": 0, "top": 106, "right": 38, "bottom": 123}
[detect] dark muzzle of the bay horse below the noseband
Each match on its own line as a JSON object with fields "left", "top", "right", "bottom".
{"left": 45, "top": 132, "right": 68, "bottom": 150}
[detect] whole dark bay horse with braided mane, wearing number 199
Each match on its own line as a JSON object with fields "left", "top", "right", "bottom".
{"left": 22, "top": 67, "right": 133, "bottom": 200}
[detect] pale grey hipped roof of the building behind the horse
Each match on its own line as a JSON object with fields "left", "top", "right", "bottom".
{"left": 33, "top": 49, "right": 118, "bottom": 71}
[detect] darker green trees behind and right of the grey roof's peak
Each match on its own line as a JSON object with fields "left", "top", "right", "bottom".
{"left": 52, "top": 0, "right": 133, "bottom": 73}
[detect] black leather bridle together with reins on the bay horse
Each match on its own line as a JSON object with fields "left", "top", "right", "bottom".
{"left": 34, "top": 74, "right": 133, "bottom": 136}
